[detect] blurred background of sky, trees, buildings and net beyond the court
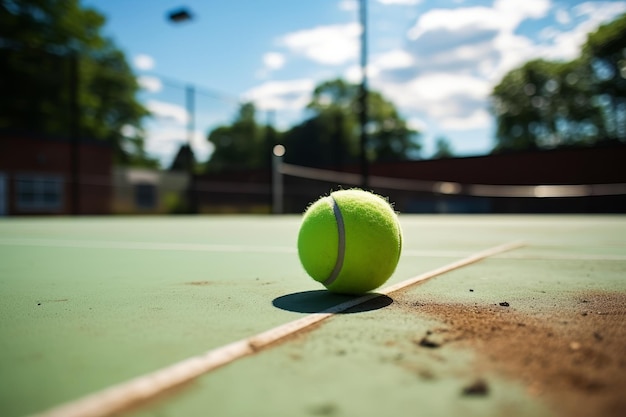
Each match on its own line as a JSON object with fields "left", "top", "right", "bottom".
{"left": 0, "top": 0, "right": 626, "bottom": 216}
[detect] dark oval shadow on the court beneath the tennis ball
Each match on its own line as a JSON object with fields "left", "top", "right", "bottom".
{"left": 272, "top": 290, "right": 393, "bottom": 314}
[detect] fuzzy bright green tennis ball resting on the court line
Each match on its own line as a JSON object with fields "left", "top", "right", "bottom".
{"left": 298, "top": 189, "right": 402, "bottom": 294}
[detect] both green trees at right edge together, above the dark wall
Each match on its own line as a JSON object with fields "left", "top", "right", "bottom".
{"left": 492, "top": 15, "right": 626, "bottom": 152}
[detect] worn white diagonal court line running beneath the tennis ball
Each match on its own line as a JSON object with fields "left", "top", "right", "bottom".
{"left": 30, "top": 242, "right": 524, "bottom": 417}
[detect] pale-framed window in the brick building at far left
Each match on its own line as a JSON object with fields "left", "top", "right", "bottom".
{"left": 15, "top": 175, "right": 63, "bottom": 211}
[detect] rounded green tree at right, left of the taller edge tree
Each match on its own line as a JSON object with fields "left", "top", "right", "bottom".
{"left": 492, "top": 60, "right": 597, "bottom": 151}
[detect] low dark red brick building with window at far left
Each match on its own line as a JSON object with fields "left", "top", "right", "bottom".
{"left": 0, "top": 133, "right": 113, "bottom": 215}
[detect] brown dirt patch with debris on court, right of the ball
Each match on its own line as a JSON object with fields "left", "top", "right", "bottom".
{"left": 405, "top": 292, "right": 626, "bottom": 417}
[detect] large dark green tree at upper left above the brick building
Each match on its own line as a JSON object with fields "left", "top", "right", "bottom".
{"left": 0, "top": 0, "right": 156, "bottom": 166}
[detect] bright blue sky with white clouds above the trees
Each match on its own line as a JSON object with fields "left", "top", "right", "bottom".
{"left": 83, "top": 0, "right": 626, "bottom": 165}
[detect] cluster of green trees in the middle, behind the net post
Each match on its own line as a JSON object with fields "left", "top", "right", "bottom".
{"left": 207, "top": 79, "right": 420, "bottom": 171}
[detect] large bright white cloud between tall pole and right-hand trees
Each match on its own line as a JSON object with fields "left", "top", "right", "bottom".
{"left": 368, "top": 0, "right": 550, "bottom": 130}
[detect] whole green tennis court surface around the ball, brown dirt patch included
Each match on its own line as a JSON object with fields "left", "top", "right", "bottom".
{"left": 0, "top": 215, "right": 626, "bottom": 417}
